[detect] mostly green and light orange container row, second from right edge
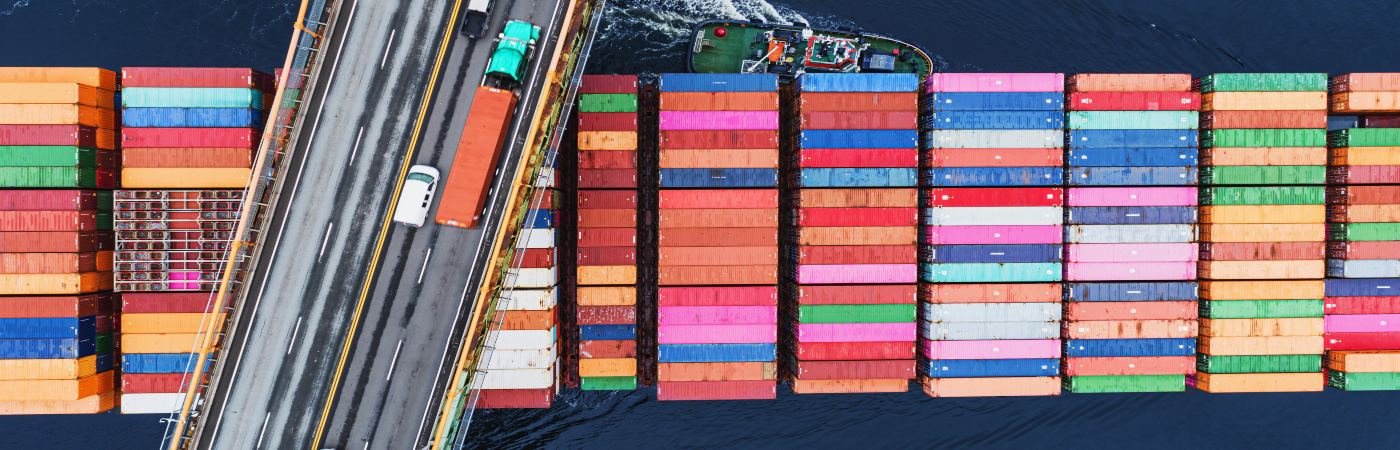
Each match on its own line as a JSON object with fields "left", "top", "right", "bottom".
{"left": 1194, "top": 73, "right": 1327, "bottom": 393}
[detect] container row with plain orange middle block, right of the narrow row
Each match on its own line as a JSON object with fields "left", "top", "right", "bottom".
{"left": 657, "top": 74, "right": 778, "bottom": 400}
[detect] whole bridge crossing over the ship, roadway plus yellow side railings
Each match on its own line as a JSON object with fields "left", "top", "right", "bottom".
{"left": 165, "top": 0, "right": 602, "bottom": 449}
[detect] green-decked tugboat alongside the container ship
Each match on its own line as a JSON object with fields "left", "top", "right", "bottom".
{"left": 686, "top": 20, "right": 934, "bottom": 80}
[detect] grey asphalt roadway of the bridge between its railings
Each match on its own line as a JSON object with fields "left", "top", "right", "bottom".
{"left": 195, "top": 0, "right": 566, "bottom": 450}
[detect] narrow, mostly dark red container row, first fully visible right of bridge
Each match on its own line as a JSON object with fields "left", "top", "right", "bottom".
{"left": 574, "top": 76, "right": 638, "bottom": 391}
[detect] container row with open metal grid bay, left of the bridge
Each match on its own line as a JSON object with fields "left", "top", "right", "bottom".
{"left": 115, "top": 67, "right": 274, "bottom": 414}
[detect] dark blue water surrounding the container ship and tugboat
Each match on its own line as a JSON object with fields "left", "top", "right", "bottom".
{"left": 0, "top": 0, "right": 1400, "bottom": 449}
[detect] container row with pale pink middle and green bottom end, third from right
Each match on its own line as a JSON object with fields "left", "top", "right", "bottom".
{"left": 1064, "top": 74, "right": 1200, "bottom": 393}
